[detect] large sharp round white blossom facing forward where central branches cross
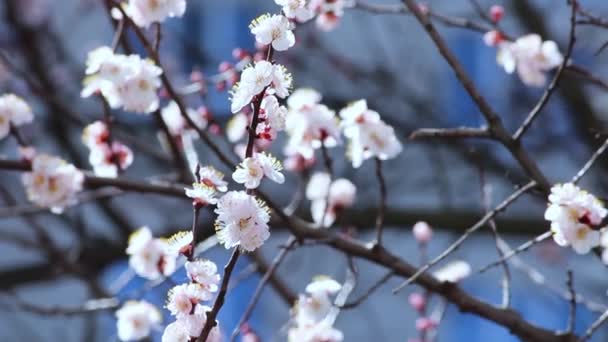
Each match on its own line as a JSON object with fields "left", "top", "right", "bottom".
{"left": 215, "top": 191, "right": 270, "bottom": 252}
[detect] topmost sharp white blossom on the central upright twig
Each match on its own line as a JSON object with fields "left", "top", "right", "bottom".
{"left": 249, "top": 14, "right": 296, "bottom": 51}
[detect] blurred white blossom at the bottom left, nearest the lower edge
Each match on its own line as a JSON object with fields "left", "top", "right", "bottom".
{"left": 116, "top": 301, "right": 162, "bottom": 341}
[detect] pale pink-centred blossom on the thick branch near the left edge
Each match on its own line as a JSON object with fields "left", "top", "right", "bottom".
{"left": 22, "top": 154, "right": 84, "bottom": 213}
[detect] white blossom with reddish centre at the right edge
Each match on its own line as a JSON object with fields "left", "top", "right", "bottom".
{"left": 545, "top": 183, "right": 608, "bottom": 254}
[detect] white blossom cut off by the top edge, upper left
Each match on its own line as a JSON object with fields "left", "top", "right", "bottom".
{"left": 125, "top": 0, "right": 186, "bottom": 28}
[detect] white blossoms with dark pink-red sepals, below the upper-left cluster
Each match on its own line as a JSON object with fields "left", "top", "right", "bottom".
{"left": 82, "top": 121, "right": 133, "bottom": 178}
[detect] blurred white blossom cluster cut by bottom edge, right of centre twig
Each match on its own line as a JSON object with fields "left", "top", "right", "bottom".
{"left": 288, "top": 276, "right": 344, "bottom": 342}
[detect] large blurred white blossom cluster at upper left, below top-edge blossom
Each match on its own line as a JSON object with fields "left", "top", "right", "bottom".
{"left": 81, "top": 46, "right": 163, "bottom": 113}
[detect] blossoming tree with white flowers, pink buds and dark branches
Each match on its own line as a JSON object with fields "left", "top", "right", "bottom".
{"left": 0, "top": 0, "right": 608, "bottom": 342}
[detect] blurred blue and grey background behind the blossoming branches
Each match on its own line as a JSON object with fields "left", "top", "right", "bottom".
{"left": 0, "top": 0, "right": 608, "bottom": 342}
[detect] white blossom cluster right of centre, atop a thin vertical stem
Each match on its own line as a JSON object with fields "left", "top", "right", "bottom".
{"left": 340, "top": 100, "right": 403, "bottom": 168}
